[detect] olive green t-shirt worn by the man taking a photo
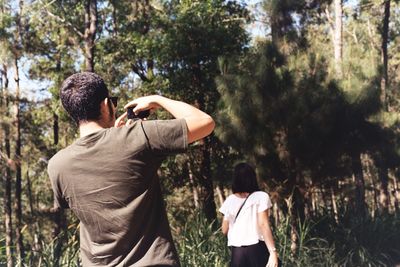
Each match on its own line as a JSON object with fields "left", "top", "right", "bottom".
{"left": 48, "top": 119, "right": 187, "bottom": 266}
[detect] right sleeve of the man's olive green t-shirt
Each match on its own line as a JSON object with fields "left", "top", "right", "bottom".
{"left": 142, "top": 119, "right": 188, "bottom": 155}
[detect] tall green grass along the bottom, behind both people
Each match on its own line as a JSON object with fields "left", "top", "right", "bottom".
{"left": 0, "top": 211, "right": 400, "bottom": 267}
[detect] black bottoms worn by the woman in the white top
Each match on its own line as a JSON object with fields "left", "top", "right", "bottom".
{"left": 229, "top": 241, "right": 281, "bottom": 267}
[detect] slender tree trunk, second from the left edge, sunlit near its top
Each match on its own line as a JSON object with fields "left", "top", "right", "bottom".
{"left": 14, "top": 58, "right": 24, "bottom": 260}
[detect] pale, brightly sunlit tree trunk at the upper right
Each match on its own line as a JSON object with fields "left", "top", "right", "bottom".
{"left": 333, "top": 0, "right": 343, "bottom": 78}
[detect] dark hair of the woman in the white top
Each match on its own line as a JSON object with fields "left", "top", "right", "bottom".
{"left": 232, "top": 162, "right": 260, "bottom": 193}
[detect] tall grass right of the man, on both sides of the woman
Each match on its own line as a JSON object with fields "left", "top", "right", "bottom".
{"left": 174, "top": 212, "right": 400, "bottom": 267}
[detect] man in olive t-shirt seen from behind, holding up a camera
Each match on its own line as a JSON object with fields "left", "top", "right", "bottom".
{"left": 48, "top": 72, "right": 214, "bottom": 266}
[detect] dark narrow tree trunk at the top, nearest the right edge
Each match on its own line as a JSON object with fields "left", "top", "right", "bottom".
{"left": 381, "top": 0, "right": 390, "bottom": 110}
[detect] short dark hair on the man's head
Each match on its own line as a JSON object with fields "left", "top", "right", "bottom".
{"left": 60, "top": 72, "right": 109, "bottom": 124}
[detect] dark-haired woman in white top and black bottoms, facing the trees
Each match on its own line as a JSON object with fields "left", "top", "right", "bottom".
{"left": 219, "top": 163, "right": 280, "bottom": 267}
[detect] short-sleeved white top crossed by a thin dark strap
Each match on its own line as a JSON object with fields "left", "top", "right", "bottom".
{"left": 219, "top": 191, "right": 272, "bottom": 247}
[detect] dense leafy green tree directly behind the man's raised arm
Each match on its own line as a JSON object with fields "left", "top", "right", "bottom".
{"left": 155, "top": 0, "right": 247, "bottom": 220}
